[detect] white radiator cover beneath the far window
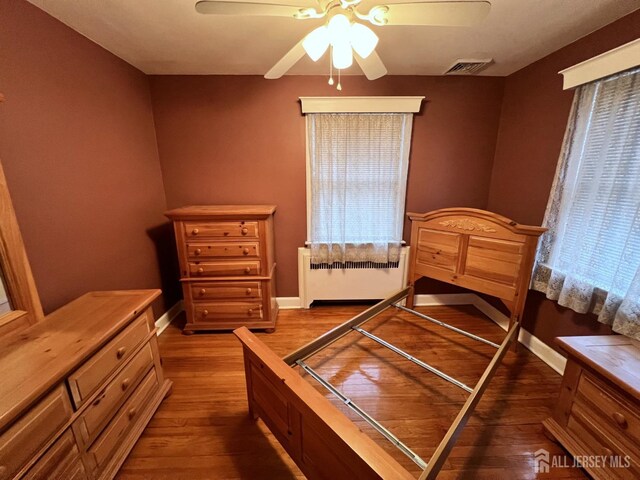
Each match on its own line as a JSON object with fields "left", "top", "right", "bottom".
{"left": 298, "top": 247, "right": 409, "bottom": 308}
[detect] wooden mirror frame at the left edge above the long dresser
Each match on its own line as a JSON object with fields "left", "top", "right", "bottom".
{"left": 0, "top": 158, "right": 44, "bottom": 336}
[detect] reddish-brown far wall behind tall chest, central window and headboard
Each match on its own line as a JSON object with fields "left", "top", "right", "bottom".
{"left": 151, "top": 76, "right": 504, "bottom": 296}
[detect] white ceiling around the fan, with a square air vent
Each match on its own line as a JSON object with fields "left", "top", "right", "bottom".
{"left": 29, "top": 0, "right": 640, "bottom": 76}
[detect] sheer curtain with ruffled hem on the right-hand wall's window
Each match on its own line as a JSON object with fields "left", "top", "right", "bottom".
{"left": 532, "top": 69, "right": 640, "bottom": 339}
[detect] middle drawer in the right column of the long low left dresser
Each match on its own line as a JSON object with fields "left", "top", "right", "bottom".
{"left": 74, "top": 344, "right": 153, "bottom": 445}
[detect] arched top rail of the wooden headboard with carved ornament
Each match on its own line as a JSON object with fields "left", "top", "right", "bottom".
{"left": 407, "top": 207, "right": 547, "bottom": 237}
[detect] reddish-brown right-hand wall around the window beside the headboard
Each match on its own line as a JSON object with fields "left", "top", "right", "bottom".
{"left": 488, "top": 10, "right": 640, "bottom": 343}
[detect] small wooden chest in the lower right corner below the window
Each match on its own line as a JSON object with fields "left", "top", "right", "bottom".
{"left": 544, "top": 335, "right": 640, "bottom": 479}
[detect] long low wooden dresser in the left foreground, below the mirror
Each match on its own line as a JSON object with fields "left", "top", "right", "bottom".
{"left": 0, "top": 290, "right": 171, "bottom": 480}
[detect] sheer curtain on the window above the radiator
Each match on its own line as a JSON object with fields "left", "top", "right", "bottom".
{"left": 307, "top": 113, "right": 413, "bottom": 264}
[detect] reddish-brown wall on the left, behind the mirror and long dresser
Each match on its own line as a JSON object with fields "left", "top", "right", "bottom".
{"left": 0, "top": 0, "right": 176, "bottom": 313}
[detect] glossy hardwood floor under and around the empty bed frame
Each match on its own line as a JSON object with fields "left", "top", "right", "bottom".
{"left": 117, "top": 306, "right": 585, "bottom": 480}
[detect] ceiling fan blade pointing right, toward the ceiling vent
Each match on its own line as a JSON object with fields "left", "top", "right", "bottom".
{"left": 374, "top": 1, "right": 491, "bottom": 27}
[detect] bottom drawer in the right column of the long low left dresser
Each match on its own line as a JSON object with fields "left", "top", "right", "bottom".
{"left": 87, "top": 370, "right": 158, "bottom": 470}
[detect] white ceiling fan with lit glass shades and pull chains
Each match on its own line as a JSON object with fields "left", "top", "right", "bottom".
{"left": 196, "top": 0, "right": 491, "bottom": 85}
